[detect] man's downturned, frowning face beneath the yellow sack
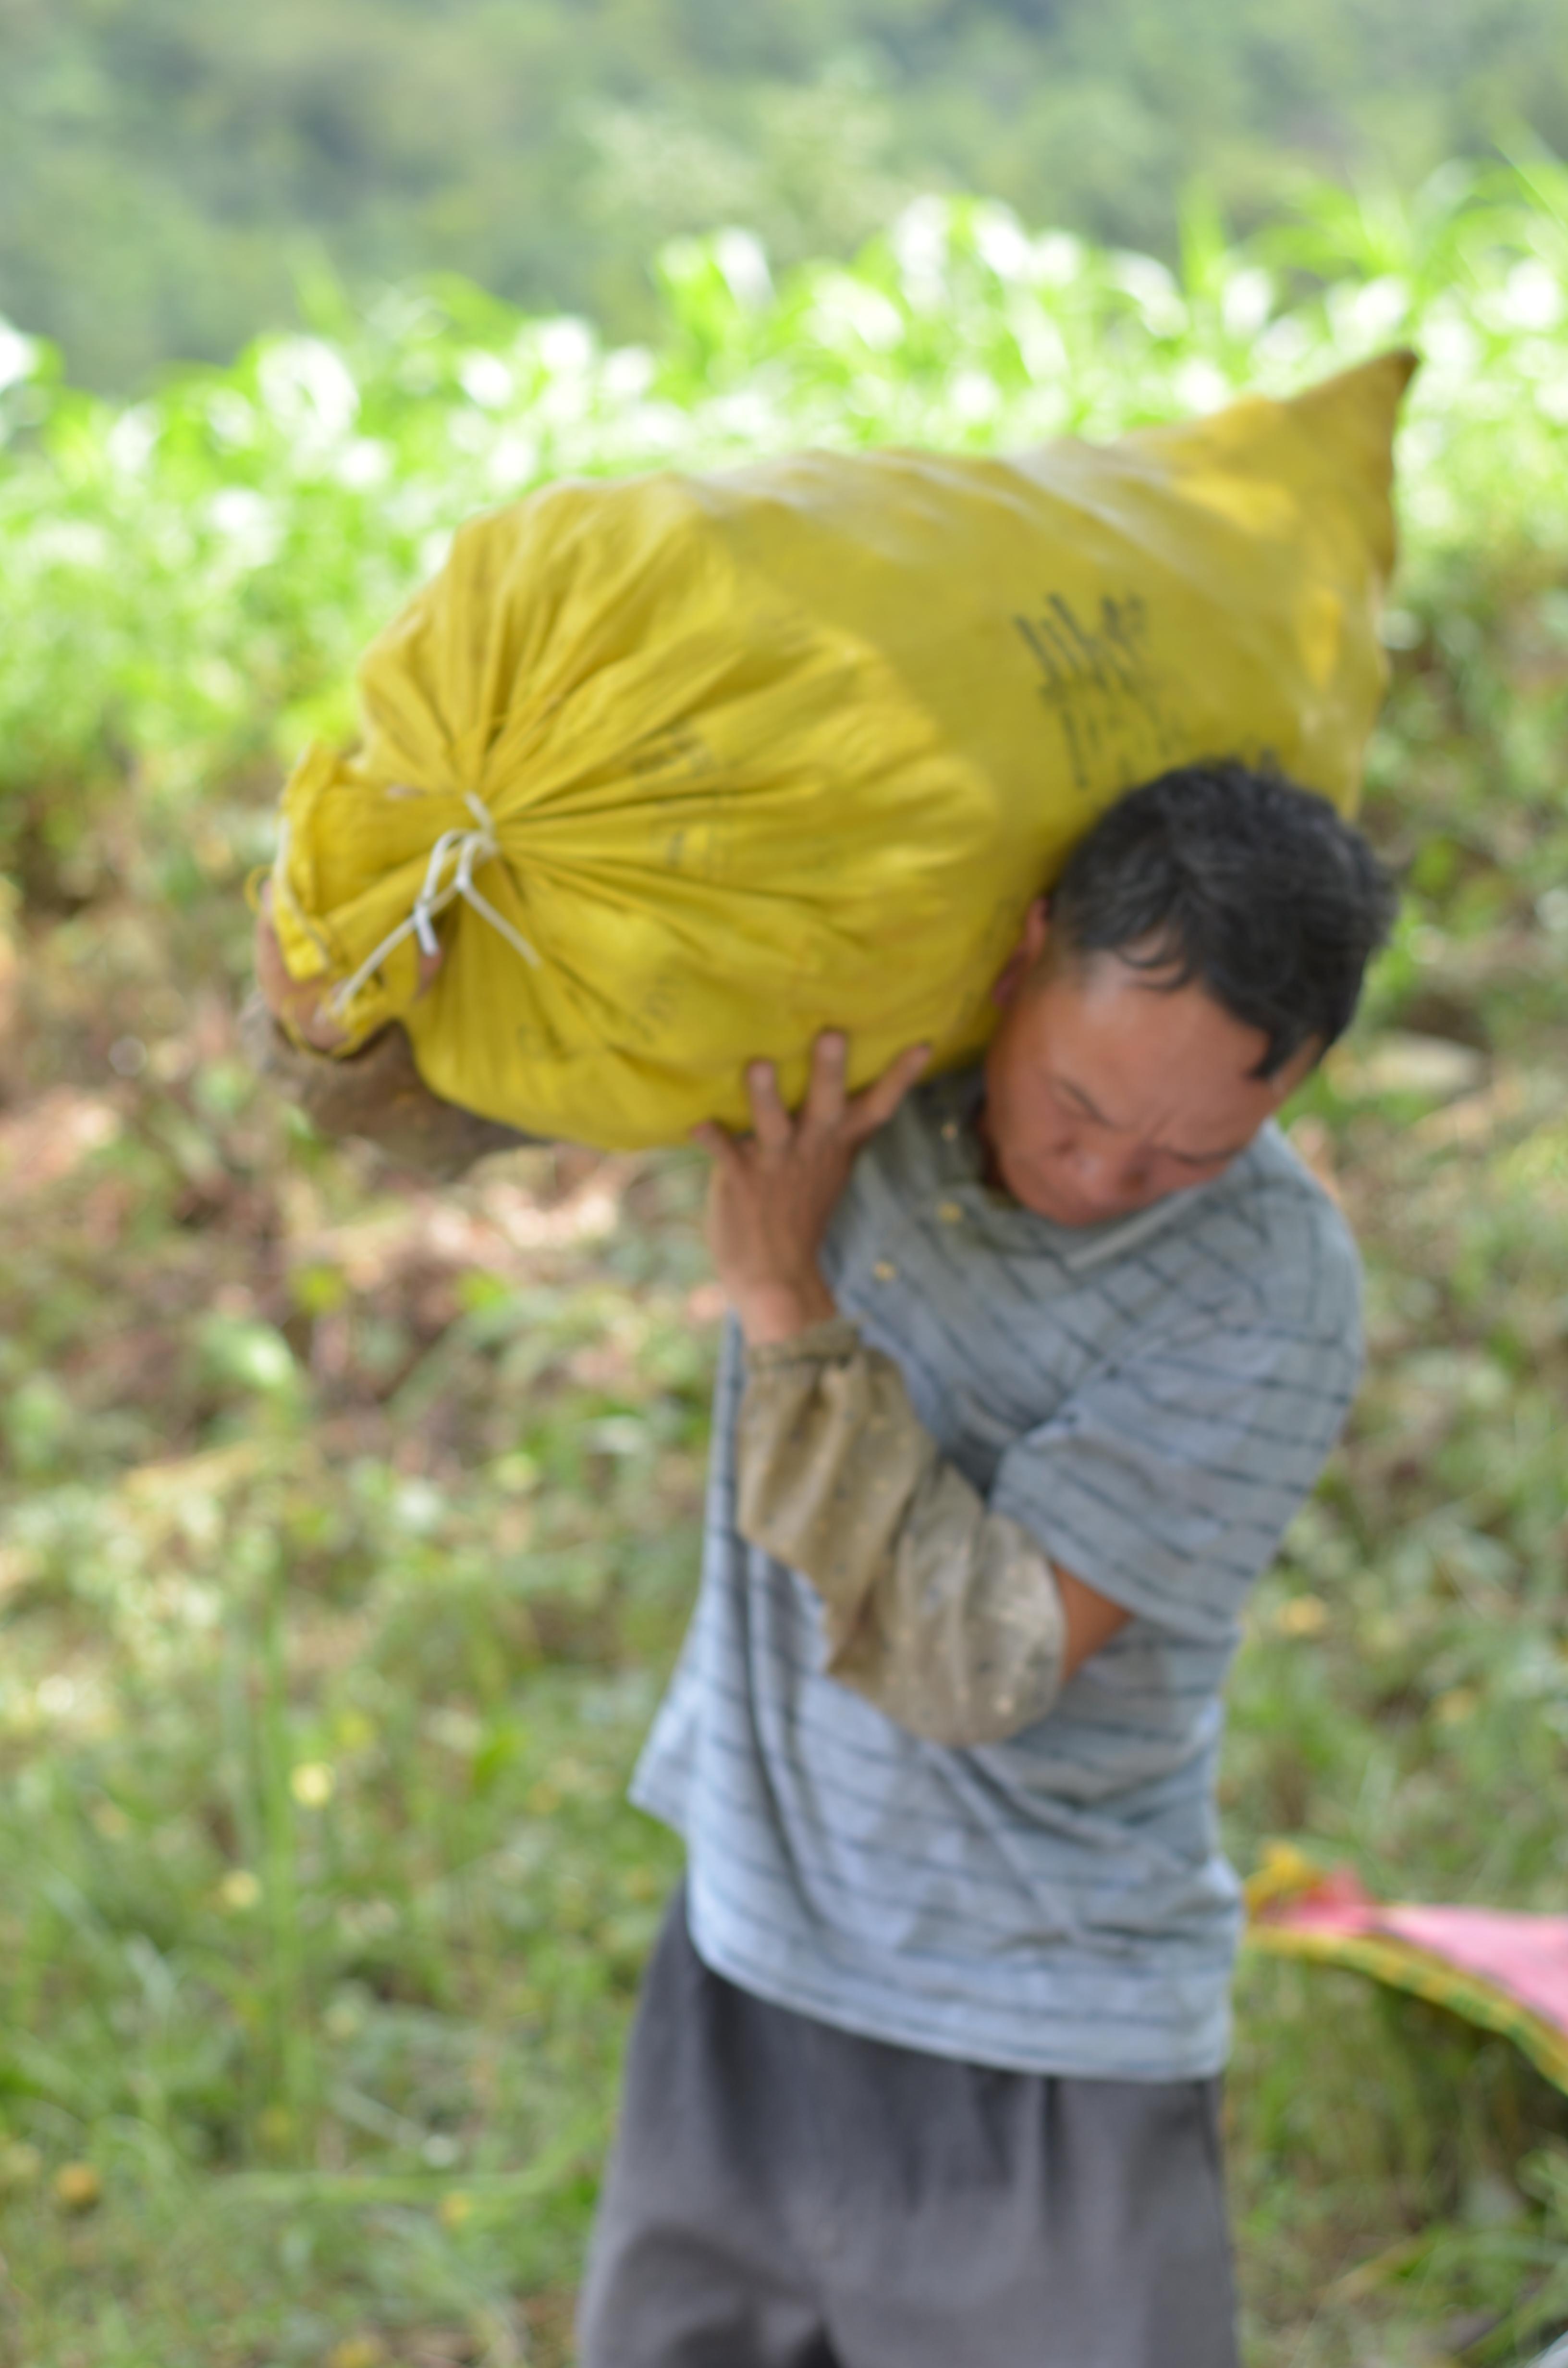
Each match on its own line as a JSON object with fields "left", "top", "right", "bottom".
{"left": 980, "top": 907, "right": 1314, "bottom": 1224}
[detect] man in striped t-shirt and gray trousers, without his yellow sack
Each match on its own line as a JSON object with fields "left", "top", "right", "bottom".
{"left": 580, "top": 765, "right": 1393, "bottom": 2368}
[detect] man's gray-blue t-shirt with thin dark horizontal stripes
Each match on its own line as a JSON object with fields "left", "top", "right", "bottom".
{"left": 632, "top": 1073, "right": 1362, "bottom": 2079}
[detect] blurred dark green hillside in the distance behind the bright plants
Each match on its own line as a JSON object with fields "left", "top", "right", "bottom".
{"left": 0, "top": 0, "right": 1568, "bottom": 388}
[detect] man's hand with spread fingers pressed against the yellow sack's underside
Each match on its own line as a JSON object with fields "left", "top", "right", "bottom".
{"left": 694, "top": 1028, "right": 931, "bottom": 1345}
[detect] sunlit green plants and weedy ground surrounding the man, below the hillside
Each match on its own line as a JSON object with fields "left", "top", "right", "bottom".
{"left": 0, "top": 161, "right": 1568, "bottom": 2368}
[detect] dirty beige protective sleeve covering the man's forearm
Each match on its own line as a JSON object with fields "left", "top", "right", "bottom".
{"left": 739, "top": 1317, "right": 1066, "bottom": 1745}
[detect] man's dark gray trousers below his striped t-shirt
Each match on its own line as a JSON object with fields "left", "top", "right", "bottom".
{"left": 578, "top": 1892, "right": 1237, "bottom": 2368}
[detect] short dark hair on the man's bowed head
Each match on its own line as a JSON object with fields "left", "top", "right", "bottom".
{"left": 1052, "top": 760, "right": 1397, "bottom": 1077}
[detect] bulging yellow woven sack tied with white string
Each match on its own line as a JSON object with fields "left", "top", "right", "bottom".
{"left": 275, "top": 353, "right": 1414, "bottom": 1148}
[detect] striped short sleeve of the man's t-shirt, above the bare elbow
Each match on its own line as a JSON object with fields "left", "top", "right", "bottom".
{"left": 990, "top": 1205, "right": 1362, "bottom": 1643}
